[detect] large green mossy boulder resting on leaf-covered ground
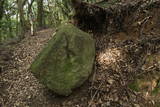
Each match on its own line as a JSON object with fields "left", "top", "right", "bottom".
{"left": 31, "top": 24, "right": 95, "bottom": 96}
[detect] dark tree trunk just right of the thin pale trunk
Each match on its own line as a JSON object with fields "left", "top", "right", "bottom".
{"left": 37, "top": 0, "right": 44, "bottom": 28}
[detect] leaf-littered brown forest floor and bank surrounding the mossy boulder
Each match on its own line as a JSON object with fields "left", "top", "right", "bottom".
{"left": 0, "top": 0, "right": 160, "bottom": 107}
